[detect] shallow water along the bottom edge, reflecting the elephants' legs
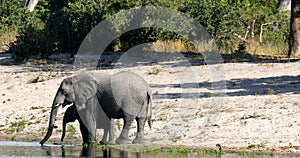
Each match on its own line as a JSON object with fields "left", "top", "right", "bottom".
{"left": 0, "top": 141, "right": 299, "bottom": 158}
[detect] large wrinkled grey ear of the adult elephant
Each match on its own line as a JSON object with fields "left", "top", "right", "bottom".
{"left": 72, "top": 72, "right": 98, "bottom": 111}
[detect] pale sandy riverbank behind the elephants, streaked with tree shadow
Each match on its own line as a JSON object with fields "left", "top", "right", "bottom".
{"left": 0, "top": 53, "right": 300, "bottom": 152}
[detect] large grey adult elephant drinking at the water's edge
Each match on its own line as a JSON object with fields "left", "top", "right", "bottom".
{"left": 40, "top": 71, "right": 152, "bottom": 145}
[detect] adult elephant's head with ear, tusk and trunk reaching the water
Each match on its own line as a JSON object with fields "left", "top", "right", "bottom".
{"left": 40, "top": 72, "right": 97, "bottom": 145}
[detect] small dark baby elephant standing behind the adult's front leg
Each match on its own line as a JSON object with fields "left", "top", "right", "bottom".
{"left": 61, "top": 104, "right": 115, "bottom": 144}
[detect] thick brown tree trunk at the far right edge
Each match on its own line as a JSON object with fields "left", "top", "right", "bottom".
{"left": 289, "top": 0, "right": 300, "bottom": 58}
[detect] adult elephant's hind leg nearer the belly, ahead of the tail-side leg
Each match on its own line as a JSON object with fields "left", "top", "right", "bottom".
{"left": 116, "top": 115, "right": 134, "bottom": 144}
